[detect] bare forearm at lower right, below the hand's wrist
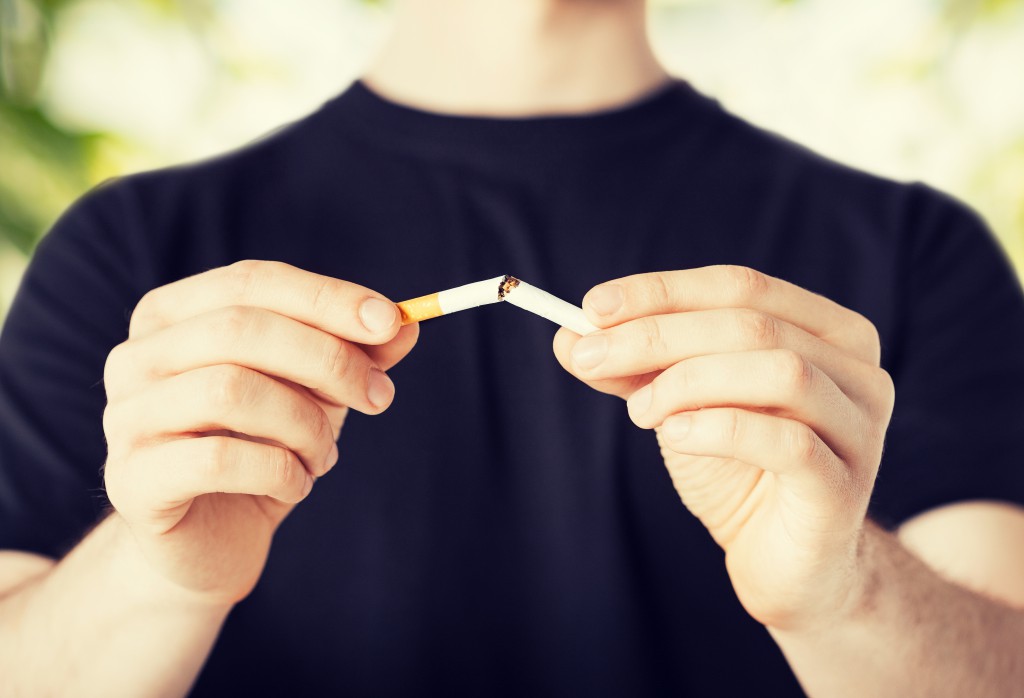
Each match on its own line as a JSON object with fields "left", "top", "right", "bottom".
{"left": 771, "top": 523, "right": 1024, "bottom": 698}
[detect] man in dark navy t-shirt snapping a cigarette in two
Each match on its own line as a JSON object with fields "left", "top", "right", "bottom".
{"left": 0, "top": 0, "right": 1024, "bottom": 697}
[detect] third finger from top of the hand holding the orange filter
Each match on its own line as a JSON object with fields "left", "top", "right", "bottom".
{"left": 103, "top": 364, "right": 338, "bottom": 477}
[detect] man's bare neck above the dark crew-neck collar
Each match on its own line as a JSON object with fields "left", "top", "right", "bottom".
{"left": 364, "top": 0, "right": 668, "bottom": 117}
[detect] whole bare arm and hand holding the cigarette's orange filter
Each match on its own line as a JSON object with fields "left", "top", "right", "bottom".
{"left": 0, "top": 261, "right": 419, "bottom": 696}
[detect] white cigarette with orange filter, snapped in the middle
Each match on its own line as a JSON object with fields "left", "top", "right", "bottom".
{"left": 398, "top": 275, "right": 597, "bottom": 335}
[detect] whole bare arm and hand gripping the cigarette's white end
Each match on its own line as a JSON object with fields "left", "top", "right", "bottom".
{"left": 554, "top": 266, "right": 1024, "bottom": 697}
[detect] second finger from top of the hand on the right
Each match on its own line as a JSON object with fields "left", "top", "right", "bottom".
{"left": 570, "top": 308, "right": 877, "bottom": 401}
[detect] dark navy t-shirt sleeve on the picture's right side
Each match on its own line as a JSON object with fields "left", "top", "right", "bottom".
{"left": 870, "top": 185, "right": 1024, "bottom": 527}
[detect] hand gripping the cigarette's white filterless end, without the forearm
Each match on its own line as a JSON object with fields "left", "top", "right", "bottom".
{"left": 554, "top": 266, "right": 894, "bottom": 629}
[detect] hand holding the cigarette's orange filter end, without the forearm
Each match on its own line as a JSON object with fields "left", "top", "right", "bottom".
{"left": 103, "top": 261, "right": 419, "bottom": 603}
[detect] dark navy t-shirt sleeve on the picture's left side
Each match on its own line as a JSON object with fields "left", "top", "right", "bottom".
{"left": 0, "top": 183, "right": 142, "bottom": 557}
